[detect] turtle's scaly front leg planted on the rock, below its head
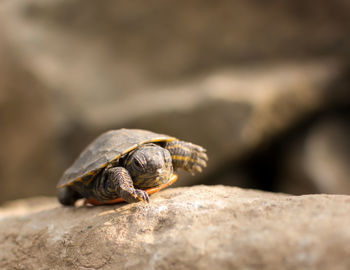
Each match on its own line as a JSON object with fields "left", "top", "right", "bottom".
{"left": 105, "top": 167, "right": 149, "bottom": 203}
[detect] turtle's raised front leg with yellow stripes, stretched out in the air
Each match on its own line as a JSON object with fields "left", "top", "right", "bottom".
{"left": 165, "top": 140, "right": 208, "bottom": 174}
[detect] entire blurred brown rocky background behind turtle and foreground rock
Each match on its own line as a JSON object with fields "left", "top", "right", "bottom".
{"left": 0, "top": 0, "right": 350, "bottom": 202}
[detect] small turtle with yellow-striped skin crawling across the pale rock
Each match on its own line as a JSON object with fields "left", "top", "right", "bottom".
{"left": 57, "top": 128, "right": 208, "bottom": 206}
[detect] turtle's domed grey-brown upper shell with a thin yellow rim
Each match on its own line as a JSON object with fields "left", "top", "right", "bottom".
{"left": 57, "top": 129, "right": 176, "bottom": 188}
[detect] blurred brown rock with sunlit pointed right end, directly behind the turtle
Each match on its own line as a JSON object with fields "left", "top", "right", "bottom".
{"left": 0, "top": 57, "right": 341, "bottom": 200}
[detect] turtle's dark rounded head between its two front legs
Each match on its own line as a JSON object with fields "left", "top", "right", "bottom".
{"left": 125, "top": 143, "right": 173, "bottom": 188}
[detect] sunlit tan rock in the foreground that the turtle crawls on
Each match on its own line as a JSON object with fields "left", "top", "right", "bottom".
{"left": 0, "top": 186, "right": 350, "bottom": 270}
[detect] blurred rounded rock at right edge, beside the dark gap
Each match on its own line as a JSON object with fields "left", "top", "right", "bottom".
{"left": 305, "top": 118, "right": 350, "bottom": 194}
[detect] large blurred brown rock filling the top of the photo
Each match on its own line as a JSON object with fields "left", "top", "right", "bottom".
{"left": 0, "top": 0, "right": 350, "bottom": 94}
